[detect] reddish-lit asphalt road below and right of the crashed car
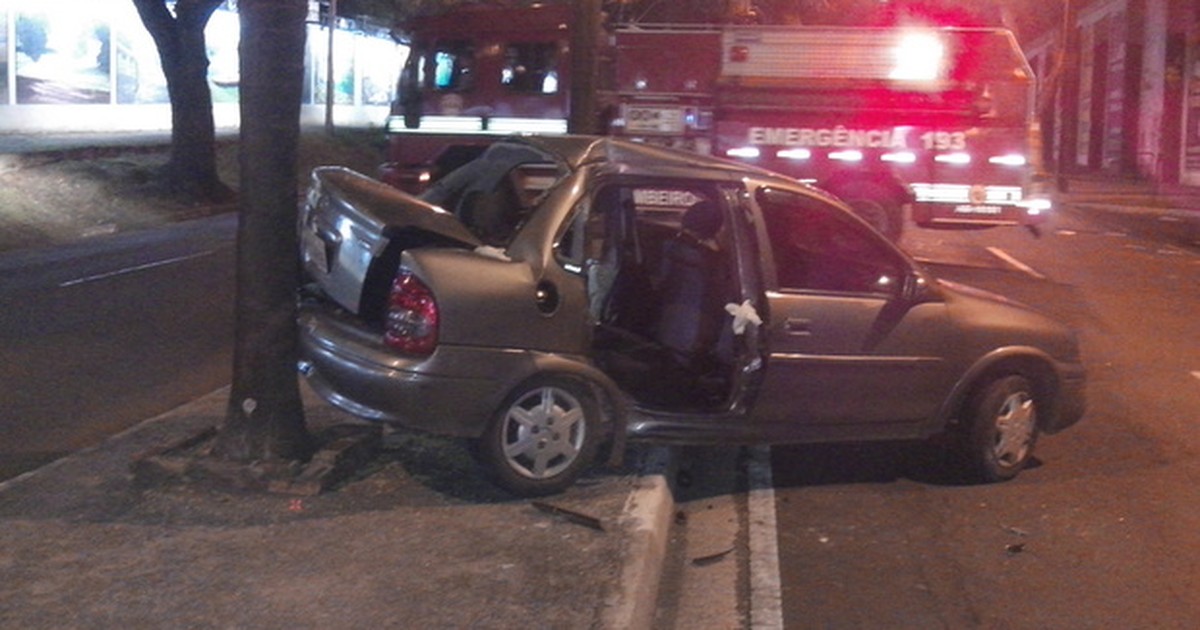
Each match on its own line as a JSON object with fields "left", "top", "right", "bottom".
{"left": 662, "top": 205, "right": 1200, "bottom": 629}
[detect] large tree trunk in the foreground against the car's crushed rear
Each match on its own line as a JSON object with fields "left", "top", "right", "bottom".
{"left": 214, "top": 0, "right": 312, "bottom": 462}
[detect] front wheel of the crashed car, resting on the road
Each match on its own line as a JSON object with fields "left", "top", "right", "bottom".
{"left": 960, "top": 376, "right": 1038, "bottom": 484}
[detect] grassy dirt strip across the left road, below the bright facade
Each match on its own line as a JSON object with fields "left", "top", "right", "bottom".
{"left": 0, "top": 131, "right": 385, "bottom": 252}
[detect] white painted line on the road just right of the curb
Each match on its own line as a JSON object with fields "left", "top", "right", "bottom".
{"left": 748, "top": 446, "right": 784, "bottom": 630}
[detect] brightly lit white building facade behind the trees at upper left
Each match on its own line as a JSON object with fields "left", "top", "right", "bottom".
{"left": 0, "top": 0, "right": 407, "bottom": 133}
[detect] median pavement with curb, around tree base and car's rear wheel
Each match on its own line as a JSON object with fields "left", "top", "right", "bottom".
{"left": 0, "top": 389, "right": 673, "bottom": 629}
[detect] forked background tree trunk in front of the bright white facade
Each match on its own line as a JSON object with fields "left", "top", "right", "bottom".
{"left": 133, "top": 0, "right": 232, "bottom": 200}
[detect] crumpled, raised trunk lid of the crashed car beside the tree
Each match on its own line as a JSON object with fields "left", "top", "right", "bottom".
{"left": 299, "top": 167, "right": 481, "bottom": 316}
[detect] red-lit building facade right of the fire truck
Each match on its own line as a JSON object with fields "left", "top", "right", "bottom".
{"left": 1025, "top": 0, "right": 1200, "bottom": 187}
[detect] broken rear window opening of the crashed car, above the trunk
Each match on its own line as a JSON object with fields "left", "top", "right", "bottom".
{"left": 421, "top": 142, "right": 566, "bottom": 247}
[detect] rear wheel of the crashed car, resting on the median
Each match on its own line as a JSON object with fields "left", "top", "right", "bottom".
{"left": 474, "top": 377, "right": 601, "bottom": 497}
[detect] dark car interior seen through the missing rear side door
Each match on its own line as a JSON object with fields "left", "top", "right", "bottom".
{"left": 587, "top": 186, "right": 737, "bottom": 412}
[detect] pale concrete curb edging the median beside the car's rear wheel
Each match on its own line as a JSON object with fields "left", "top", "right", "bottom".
{"left": 601, "top": 448, "right": 676, "bottom": 630}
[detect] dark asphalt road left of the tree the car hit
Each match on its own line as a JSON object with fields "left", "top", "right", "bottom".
{"left": 0, "top": 215, "right": 236, "bottom": 480}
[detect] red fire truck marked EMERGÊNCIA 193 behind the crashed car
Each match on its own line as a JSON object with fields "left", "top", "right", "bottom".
{"left": 383, "top": 5, "right": 1050, "bottom": 239}
